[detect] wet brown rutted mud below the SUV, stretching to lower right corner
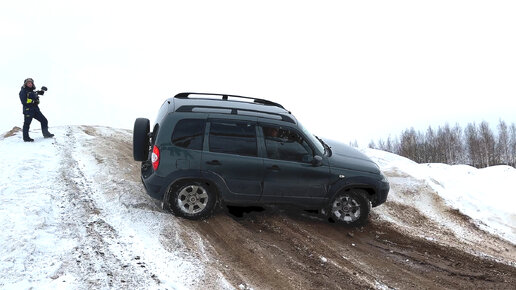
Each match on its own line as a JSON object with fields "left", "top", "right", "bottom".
{"left": 192, "top": 210, "right": 516, "bottom": 289}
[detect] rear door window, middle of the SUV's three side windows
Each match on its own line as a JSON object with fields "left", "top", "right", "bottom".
{"left": 209, "top": 121, "right": 258, "bottom": 156}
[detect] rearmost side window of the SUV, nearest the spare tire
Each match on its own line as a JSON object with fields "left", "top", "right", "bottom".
{"left": 172, "top": 119, "right": 206, "bottom": 150}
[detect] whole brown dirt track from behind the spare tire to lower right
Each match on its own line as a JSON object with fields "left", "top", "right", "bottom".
{"left": 83, "top": 127, "right": 516, "bottom": 289}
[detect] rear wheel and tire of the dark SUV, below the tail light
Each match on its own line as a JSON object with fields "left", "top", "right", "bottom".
{"left": 163, "top": 181, "right": 217, "bottom": 220}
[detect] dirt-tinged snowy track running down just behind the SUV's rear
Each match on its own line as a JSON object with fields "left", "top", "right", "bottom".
{"left": 80, "top": 126, "right": 231, "bottom": 289}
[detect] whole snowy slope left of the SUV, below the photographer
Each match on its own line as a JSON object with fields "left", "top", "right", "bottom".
{"left": 0, "top": 127, "right": 230, "bottom": 289}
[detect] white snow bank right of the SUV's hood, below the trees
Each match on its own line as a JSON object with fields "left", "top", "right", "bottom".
{"left": 362, "top": 149, "right": 516, "bottom": 244}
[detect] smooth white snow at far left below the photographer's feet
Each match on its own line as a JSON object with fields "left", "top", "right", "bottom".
{"left": 0, "top": 127, "right": 77, "bottom": 288}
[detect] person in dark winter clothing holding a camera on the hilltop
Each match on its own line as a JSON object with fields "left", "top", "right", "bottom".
{"left": 20, "top": 78, "right": 54, "bottom": 142}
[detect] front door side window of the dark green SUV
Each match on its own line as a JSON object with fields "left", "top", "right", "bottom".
{"left": 262, "top": 126, "right": 314, "bottom": 163}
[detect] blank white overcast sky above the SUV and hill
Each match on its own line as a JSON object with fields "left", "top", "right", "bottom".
{"left": 0, "top": 0, "right": 516, "bottom": 145}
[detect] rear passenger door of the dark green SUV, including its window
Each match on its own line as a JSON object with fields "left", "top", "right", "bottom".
{"left": 201, "top": 120, "right": 263, "bottom": 201}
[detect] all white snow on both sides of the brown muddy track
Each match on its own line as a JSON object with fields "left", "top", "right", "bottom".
{"left": 0, "top": 126, "right": 516, "bottom": 289}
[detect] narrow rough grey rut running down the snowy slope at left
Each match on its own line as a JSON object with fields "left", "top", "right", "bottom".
{"left": 54, "top": 127, "right": 158, "bottom": 289}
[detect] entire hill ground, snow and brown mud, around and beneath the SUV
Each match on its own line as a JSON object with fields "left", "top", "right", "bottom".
{"left": 0, "top": 126, "right": 516, "bottom": 289}
